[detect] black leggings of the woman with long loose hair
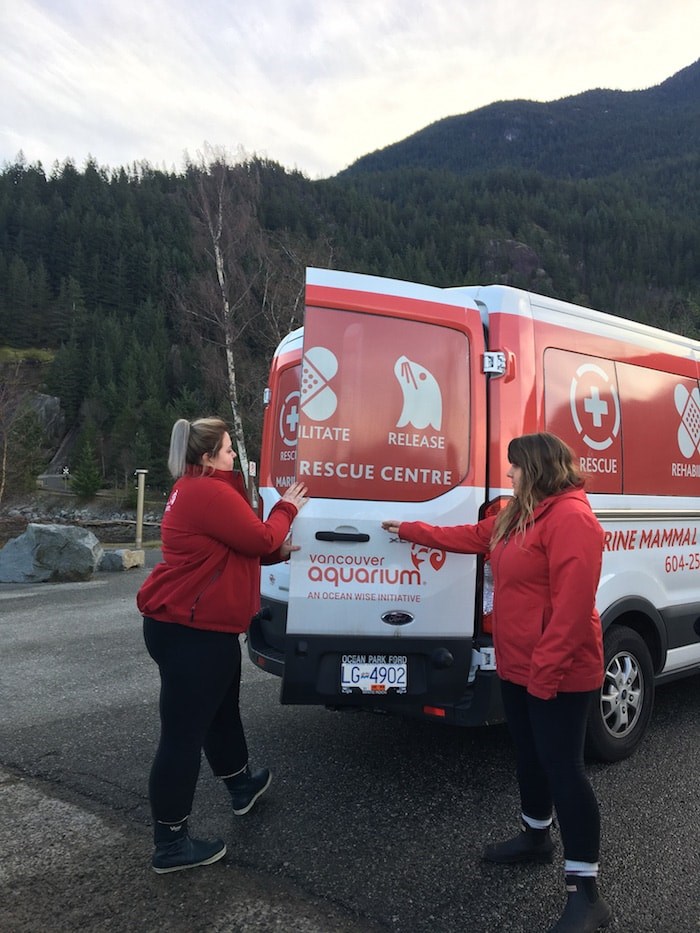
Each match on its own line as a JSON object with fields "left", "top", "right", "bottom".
{"left": 501, "top": 680, "right": 600, "bottom": 863}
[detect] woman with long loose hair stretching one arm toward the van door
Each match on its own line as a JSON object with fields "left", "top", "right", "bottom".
{"left": 382, "top": 434, "right": 611, "bottom": 933}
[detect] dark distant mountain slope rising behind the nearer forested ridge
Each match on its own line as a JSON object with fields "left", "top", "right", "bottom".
{"left": 336, "top": 59, "right": 700, "bottom": 178}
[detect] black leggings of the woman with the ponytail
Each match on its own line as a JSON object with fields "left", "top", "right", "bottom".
{"left": 143, "top": 617, "right": 248, "bottom": 823}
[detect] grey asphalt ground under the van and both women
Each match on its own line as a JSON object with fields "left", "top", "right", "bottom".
{"left": 0, "top": 570, "right": 700, "bottom": 933}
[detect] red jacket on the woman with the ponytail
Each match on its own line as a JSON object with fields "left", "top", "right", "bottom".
{"left": 136, "top": 470, "right": 297, "bottom": 632}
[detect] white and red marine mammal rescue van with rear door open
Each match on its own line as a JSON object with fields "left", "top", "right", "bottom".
{"left": 248, "top": 269, "right": 700, "bottom": 760}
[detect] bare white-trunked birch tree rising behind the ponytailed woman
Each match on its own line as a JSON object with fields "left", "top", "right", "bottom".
{"left": 178, "top": 147, "right": 328, "bottom": 505}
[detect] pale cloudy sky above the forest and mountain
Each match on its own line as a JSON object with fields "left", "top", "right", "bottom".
{"left": 0, "top": 0, "right": 700, "bottom": 179}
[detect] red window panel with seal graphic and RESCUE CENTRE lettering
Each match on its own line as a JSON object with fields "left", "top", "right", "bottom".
{"left": 297, "top": 308, "right": 470, "bottom": 502}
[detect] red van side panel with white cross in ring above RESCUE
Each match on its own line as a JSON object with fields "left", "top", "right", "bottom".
{"left": 544, "top": 349, "right": 623, "bottom": 493}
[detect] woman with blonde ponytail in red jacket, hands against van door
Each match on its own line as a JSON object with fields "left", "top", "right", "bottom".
{"left": 137, "top": 418, "right": 307, "bottom": 874}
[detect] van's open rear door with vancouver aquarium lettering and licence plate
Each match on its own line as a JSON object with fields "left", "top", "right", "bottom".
{"left": 282, "top": 269, "right": 487, "bottom": 708}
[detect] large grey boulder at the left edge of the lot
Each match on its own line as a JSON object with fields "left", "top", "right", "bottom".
{"left": 0, "top": 523, "right": 104, "bottom": 583}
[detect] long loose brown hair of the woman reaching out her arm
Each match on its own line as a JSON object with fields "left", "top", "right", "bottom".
{"left": 491, "top": 433, "right": 583, "bottom": 547}
